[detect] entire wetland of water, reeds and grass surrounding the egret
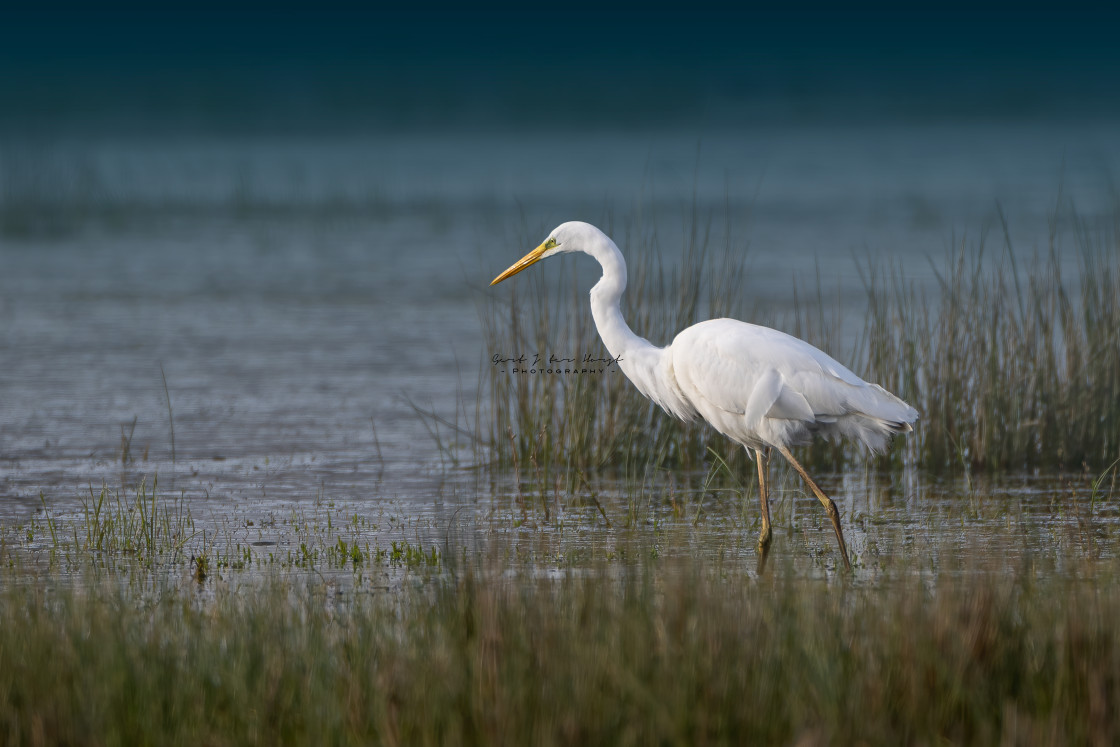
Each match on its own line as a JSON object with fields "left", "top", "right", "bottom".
{"left": 0, "top": 125, "right": 1120, "bottom": 745}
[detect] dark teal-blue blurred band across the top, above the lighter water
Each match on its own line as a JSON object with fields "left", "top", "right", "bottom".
{"left": 0, "top": 2, "right": 1120, "bottom": 133}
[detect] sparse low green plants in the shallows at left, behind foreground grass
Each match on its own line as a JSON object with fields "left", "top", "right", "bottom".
{"left": 8, "top": 477, "right": 444, "bottom": 586}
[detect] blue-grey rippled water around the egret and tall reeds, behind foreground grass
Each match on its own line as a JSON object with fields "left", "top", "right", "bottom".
{"left": 0, "top": 124, "right": 1120, "bottom": 569}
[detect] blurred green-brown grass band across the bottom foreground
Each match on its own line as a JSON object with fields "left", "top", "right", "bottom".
{"left": 0, "top": 548, "right": 1120, "bottom": 745}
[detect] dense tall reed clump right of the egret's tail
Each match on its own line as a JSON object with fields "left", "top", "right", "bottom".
{"left": 864, "top": 215, "right": 1120, "bottom": 471}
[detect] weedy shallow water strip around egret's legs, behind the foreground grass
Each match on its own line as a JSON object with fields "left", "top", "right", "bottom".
{"left": 8, "top": 465, "right": 1120, "bottom": 591}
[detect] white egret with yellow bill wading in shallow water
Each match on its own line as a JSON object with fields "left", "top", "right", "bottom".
{"left": 491, "top": 222, "right": 917, "bottom": 568}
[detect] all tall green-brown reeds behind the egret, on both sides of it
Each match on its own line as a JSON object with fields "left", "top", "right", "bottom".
{"left": 478, "top": 201, "right": 1120, "bottom": 479}
